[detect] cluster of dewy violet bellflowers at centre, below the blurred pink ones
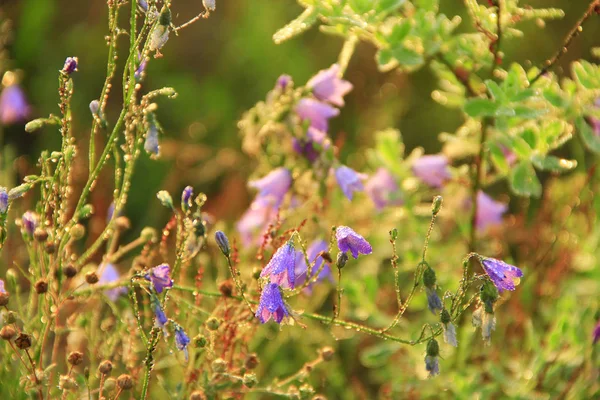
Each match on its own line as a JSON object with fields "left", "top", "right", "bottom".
{"left": 256, "top": 226, "right": 373, "bottom": 324}
